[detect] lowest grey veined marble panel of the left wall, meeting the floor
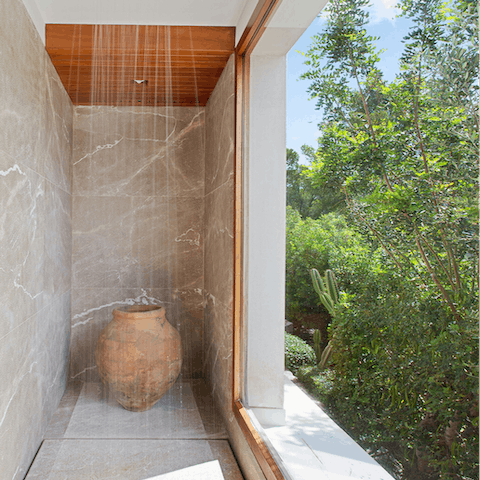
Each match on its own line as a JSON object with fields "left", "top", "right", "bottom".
{"left": 0, "top": 292, "right": 70, "bottom": 479}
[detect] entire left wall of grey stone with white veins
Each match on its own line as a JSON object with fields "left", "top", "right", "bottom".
{"left": 0, "top": 0, "right": 73, "bottom": 480}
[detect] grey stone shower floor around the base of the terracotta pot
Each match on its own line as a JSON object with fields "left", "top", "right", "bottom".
{"left": 26, "top": 381, "right": 243, "bottom": 480}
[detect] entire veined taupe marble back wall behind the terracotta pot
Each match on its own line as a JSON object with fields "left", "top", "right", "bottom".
{"left": 70, "top": 107, "right": 205, "bottom": 381}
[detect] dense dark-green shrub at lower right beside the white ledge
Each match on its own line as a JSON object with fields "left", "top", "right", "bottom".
{"left": 330, "top": 271, "right": 479, "bottom": 480}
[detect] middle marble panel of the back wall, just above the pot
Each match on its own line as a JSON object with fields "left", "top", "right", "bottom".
{"left": 73, "top": 196, "right": 203, "bottom": 289}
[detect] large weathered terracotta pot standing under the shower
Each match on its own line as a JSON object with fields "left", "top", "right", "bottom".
{"left": 95, "top": 305, "right": 182, "bottom": 412}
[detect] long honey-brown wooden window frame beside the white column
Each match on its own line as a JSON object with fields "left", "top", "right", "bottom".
{"left": 232, "top": 0, "right": 285, "bottom": 480}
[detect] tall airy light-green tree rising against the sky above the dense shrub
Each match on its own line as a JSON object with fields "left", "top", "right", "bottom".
{"left": 304, "top": 0, "right": 480, "bottom": 320}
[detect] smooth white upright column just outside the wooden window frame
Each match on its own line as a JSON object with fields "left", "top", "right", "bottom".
{"left": 244, "top": 55, "right": 286, "bottom": 425}
